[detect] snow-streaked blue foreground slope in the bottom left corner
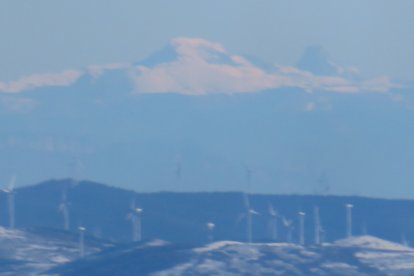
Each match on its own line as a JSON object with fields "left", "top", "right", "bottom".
{"left": 0, "top": 226, "right": 111, "bottom": 275}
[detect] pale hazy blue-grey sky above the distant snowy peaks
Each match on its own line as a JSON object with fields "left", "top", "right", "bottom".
{"left": 0, "top": 0, "right": 414, "bottom": 81}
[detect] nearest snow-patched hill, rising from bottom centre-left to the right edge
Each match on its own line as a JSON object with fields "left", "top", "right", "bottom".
{"left": 51, "top": 236, "right": 414, "bottom": 276}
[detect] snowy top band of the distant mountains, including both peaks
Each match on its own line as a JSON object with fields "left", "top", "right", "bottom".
{"left": 0, "top": 37, "right": 395, "bottom": 95}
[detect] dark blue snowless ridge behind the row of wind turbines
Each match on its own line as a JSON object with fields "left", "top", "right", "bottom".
{"left": 0, "top": 180, "right": 414, "bottom": 244}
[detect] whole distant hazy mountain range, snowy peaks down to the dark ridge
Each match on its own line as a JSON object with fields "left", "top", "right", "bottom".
{"left": 0, "top": 38, "right": 414, "bottom": 197}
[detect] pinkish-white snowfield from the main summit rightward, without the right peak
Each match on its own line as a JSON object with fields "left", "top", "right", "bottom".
{"left": 131, "top": 38, "right": 395, "bottom": 95}
